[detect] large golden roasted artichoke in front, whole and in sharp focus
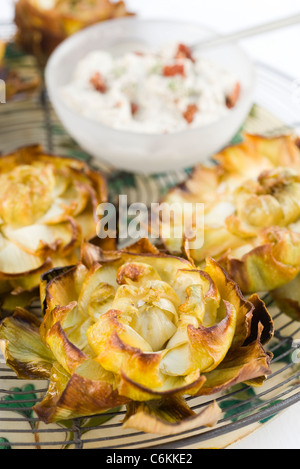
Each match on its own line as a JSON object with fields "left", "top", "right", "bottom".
{"left": 0, "top": 240, "right": 273, "bottom": 434}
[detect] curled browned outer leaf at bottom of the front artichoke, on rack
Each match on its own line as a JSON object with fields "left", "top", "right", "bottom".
{"left": 123, "top": 396, "right": 221, "bottom": 435}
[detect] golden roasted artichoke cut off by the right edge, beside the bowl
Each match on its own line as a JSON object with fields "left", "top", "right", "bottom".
{"left": 161, "top": 135, "right": 300, "bottom": 294}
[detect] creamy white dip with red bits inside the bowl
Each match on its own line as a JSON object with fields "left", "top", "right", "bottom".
{"left": 61, "top": 44, "right": 240, "bottom": 134}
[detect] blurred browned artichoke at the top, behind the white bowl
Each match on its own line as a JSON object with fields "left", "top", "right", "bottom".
{"left": 15, "top": 0, "right": 135, "bottom": 63}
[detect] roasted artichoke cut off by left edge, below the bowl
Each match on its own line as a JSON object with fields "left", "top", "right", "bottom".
{"left": 0, "top": 146, "right": 106, "bottom": 313}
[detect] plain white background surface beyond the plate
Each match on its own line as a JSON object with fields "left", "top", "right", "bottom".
{"left": 0, "top": 0, "right": 300, "bottom": 449}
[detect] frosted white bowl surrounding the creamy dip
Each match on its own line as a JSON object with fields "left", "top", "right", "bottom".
{"left": 46, "top": 18, "right": 255, "bottom": 174}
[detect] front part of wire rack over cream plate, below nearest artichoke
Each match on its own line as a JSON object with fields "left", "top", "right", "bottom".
{"left": 0, "top": 297, "right": 300, "bottom": 449}
